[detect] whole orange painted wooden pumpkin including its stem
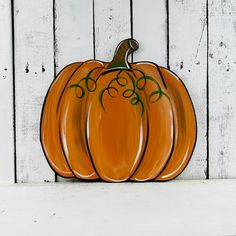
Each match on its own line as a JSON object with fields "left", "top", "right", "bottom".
{"left": 41, "top": 39, "right": 196, "bottom": 182}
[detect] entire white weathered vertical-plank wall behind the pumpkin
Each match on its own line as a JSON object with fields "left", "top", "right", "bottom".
{"left": 0, "top": 0, "right": 236, "bottom": 182}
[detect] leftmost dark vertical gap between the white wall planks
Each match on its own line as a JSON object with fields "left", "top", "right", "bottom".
{"left": 11, "top": 0, "right": 17, "bottom": 183}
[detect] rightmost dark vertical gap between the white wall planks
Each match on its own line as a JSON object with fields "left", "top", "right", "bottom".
{"left": 206, "top": 0, "right": 210, "bottom": 179}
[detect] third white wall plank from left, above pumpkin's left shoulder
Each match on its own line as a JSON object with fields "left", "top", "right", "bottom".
{"left": 55, "top": 0, "right": 93, "bottom": 182}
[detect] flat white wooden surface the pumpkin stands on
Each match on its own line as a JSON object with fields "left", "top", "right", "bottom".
{"left": 0, "top": 180, "right": 236, "bottom": 236}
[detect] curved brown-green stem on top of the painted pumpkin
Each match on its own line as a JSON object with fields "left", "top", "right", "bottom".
{"left": 107, "top": 39, "right": 138, "bottom": 69}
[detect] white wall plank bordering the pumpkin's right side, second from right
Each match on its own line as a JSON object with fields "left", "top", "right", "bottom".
{"left": 169, "top": 0, "right": 207, "bottom": 179}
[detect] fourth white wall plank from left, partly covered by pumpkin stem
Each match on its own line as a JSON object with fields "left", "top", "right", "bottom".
{"left": 94, "top": 0, "right": 131, "bottom": 61}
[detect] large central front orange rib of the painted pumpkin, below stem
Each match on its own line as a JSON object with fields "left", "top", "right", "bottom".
{"left": 86, "top": 70, "right": 146, "bottom": 182}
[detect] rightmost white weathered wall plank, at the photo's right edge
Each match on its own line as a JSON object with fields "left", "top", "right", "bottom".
{"left": 208, "top": 0, "right": 236, "bottom": 178}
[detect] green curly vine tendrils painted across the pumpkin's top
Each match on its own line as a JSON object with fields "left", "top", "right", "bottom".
{"left": 69, "top": 67, "right": 169, "bottom": 114}
